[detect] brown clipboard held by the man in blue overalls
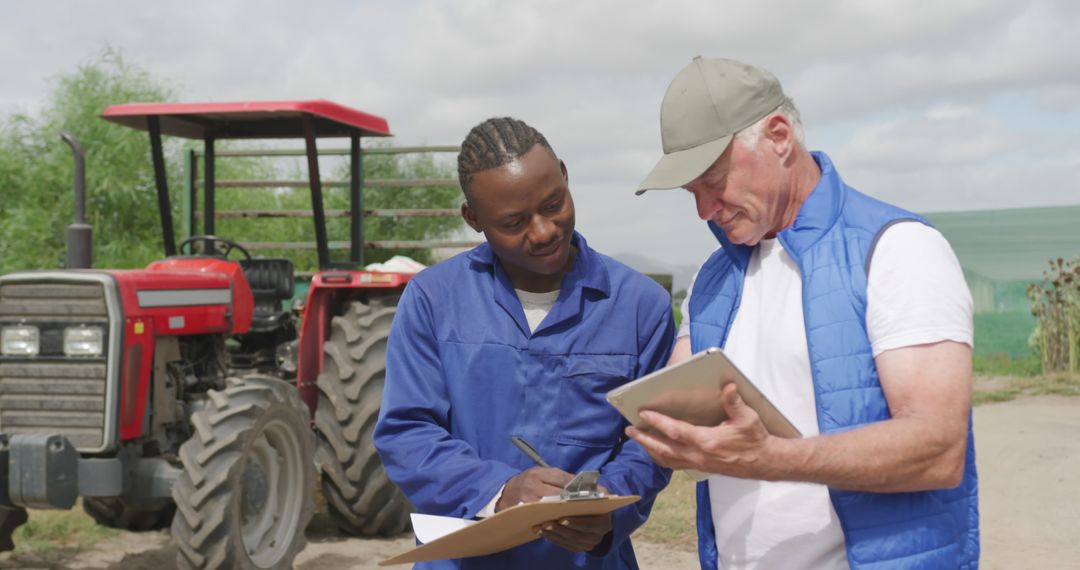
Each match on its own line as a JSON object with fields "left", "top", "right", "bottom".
{"left": 379, "top": 494, "right": 640, "bottom": 566}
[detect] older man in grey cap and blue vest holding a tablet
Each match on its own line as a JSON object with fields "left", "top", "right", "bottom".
{"left": 627, "top": 57, "right": 978, "bottom": 569}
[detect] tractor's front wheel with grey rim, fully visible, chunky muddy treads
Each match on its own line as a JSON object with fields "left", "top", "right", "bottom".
{"left": 172, "top": 376, "right": 315, "bottom": 570}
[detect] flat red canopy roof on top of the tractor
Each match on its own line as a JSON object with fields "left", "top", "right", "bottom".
{"left": 102, "top": 99, "right": 390, "bottom": 139}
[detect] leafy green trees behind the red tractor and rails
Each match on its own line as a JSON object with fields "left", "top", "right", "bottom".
{"left": 0, "top": 50, "right": 462, "bottom": 272}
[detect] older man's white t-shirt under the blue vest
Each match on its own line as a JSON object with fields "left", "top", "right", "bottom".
{"left": 679, "top": 222, "right": 973, "bottom": 569}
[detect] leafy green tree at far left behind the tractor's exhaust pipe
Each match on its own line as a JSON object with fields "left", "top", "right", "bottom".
{"left": 0, "top": 50, "right": 180, "bottom": 271}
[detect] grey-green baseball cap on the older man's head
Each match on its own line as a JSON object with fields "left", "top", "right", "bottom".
{"left": 635, "top": 55, "right": 785, "bottom": 194}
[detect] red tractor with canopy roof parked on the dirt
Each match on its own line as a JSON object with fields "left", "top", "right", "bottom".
{"left": 0, "top": 100, "right": 471, "bottom": 569}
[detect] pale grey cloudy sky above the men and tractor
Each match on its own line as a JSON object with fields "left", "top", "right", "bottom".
{"left": 0, "top": 0, "right": 1080, "bottom": 274}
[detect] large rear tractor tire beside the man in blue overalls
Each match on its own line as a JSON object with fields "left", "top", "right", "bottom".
{"left": 315, "top": 295, "right": 413, "bottom": 537}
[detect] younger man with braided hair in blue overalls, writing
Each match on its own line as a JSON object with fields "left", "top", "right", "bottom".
{"left": 375, "top": 119, "right": 674, "bottom": 570}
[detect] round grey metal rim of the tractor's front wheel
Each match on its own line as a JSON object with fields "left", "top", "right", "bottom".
{"left": 241, "top": 420, "right": 305, "bottom": 568}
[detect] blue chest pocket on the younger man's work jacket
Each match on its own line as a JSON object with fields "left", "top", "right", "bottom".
{"left": 557, "top": 354, "right": 634, "bottom": 447}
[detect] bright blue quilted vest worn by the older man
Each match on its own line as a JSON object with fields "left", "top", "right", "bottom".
{"left": 689, "top": 152, "right": 978, "bottom": 570}
